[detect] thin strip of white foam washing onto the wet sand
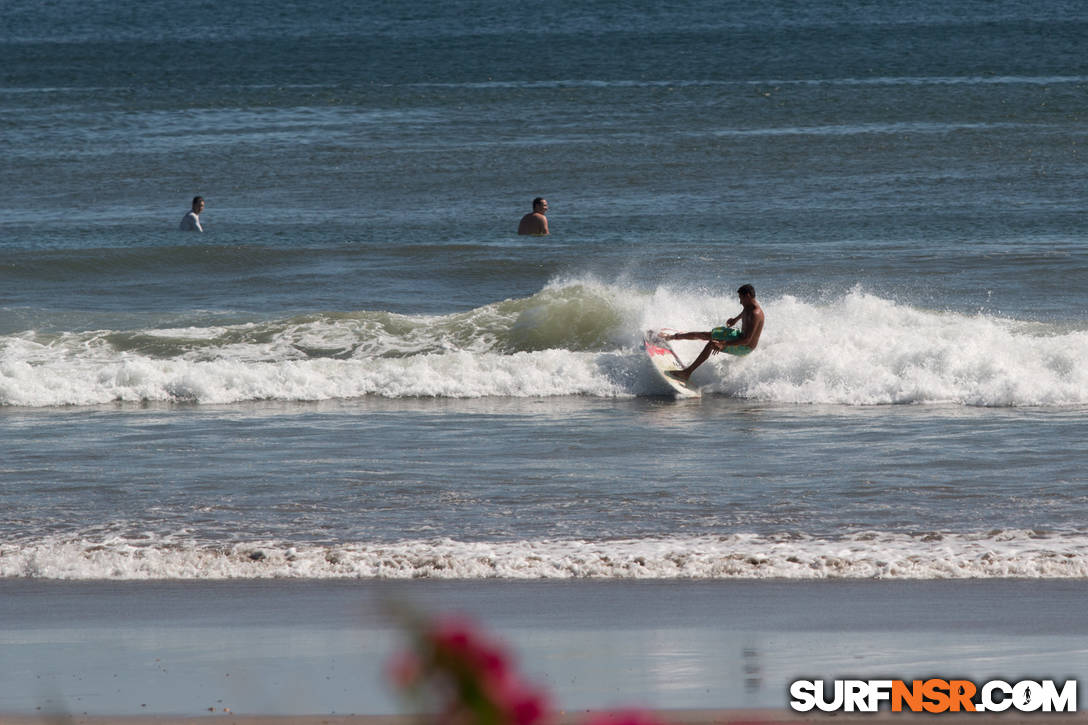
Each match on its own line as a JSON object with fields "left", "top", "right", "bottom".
{"left": 0, "top": 531, "right": 1088, "bottom": 579}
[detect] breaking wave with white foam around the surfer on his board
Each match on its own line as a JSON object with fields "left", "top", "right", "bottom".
{"left": 0, "top": 280, "right": 1088, "bottom": 407}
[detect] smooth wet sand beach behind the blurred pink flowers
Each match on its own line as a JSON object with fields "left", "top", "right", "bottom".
{"left": 0, "top": 579, "right": 1088, "bottom": 725}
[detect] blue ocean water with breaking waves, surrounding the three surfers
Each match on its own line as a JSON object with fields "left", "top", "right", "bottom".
{"left": 0, "top": 0, "right": 1088, "bottom": 580}
